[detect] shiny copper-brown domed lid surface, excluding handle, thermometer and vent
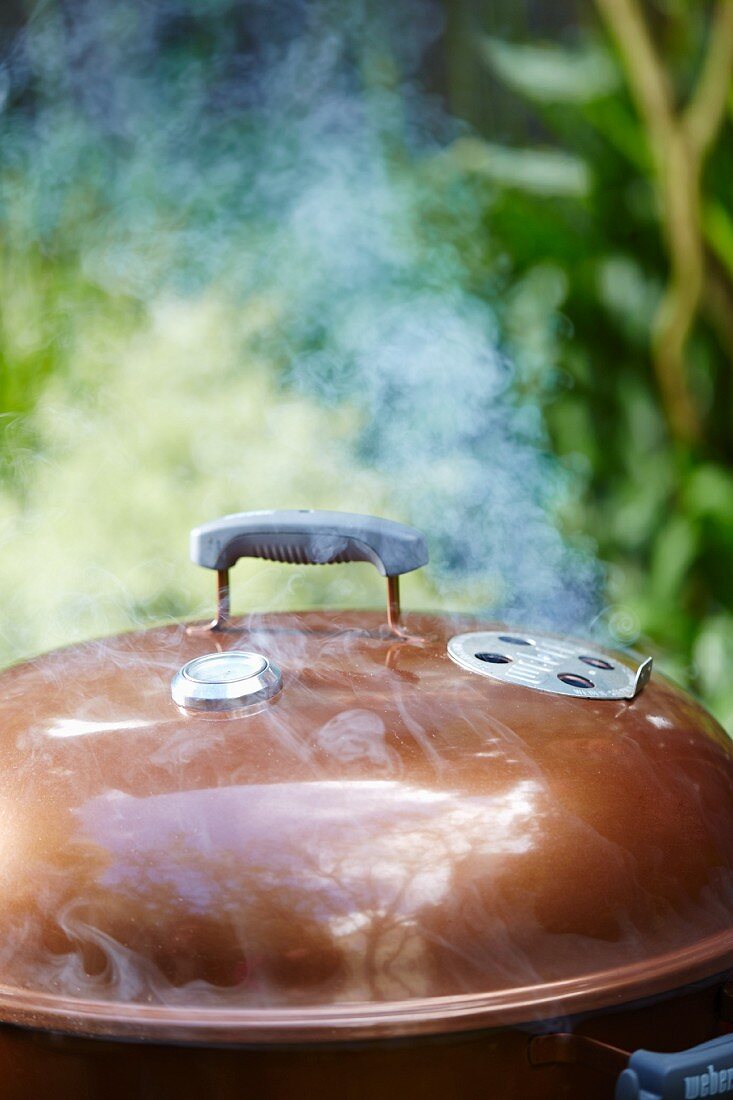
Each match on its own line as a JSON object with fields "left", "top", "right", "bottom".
{"left": 0, "top": 613, "right": 733, "bottom": 1042}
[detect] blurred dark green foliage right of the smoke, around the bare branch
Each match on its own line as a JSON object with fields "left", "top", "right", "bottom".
{"left": 444, "top": 4, "right": 733, "bottom": 729}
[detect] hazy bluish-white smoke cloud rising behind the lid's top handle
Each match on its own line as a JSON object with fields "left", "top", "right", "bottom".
{"left": 0, "top": 0, "right": 600, "bottom": 658}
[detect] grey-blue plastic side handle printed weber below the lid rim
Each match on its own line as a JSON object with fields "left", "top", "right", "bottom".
{"left": 616, "top": 1035, "right": 733, "bottom": 1100}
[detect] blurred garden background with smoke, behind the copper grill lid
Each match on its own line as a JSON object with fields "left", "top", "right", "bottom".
{"left": 0, "top": 0, "right": 733, "bottom": 732}
